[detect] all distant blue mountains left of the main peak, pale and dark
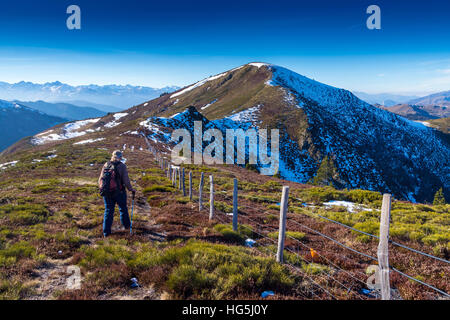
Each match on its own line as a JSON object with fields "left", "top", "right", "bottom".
{"left": 0, "top": 81, "right": 178, "bottom": 151}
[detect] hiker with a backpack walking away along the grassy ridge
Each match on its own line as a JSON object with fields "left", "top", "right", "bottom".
{"left": 98, "top": 150, "right": 136, "bottom": 237}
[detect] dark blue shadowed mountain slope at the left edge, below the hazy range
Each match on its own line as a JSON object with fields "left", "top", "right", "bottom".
{"left": 0, "top": 100, "right": 68, "bottom": 151}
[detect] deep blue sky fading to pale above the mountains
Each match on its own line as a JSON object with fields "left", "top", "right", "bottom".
{"left": 0, "top": 0, "right": 450, "bottom": 94}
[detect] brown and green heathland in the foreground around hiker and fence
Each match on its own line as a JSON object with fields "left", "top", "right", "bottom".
{"left": 0, "top": 135, "right": 450, "bottom": 299}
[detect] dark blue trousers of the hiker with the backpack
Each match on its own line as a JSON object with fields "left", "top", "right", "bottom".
{"left": 103, "top": 191, "right": 130, "bottom": 237}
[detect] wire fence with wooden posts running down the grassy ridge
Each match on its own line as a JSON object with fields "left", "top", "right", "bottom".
{"left": 146, "top": 142, "right": 450, "bottom": 299}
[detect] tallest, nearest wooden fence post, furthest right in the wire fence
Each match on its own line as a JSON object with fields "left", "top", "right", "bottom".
{"left": 377, "top": 193, "right": 391, "bottom": 300}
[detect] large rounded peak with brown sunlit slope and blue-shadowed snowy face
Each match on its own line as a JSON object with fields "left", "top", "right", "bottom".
{"left": 4, "top": 63, "right": 450, "bottom": 201}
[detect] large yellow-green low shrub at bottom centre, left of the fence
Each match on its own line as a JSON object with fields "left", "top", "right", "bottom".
{"left": 161, "top": 241, "right": 295, "bottom": 299}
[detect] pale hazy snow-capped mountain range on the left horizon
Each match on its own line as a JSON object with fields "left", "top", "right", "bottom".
{"left": 0, "top": 81, "right": 178, "bottom": 112}
